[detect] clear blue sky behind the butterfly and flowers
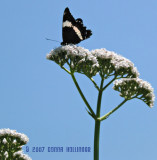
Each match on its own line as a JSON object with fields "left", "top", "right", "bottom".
{"left": 0, "top": 0, "right": 157, "bottom": 160}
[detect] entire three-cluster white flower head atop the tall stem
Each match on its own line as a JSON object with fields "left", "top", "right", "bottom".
{"left": 47, "top": 45, "right": 155, "bottom": 107}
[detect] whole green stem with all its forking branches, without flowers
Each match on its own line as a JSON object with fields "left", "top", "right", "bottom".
{"left": 61, "top": 63, "right": 127, "bottom": 160}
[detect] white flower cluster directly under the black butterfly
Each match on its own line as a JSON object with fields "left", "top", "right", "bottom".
{"left": 47, "top": 45, "right": 99, "bottom": 77}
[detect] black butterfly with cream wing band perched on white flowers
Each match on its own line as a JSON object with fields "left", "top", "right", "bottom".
{"left": 61, "top": 8, "right": 92, "bottom": 45}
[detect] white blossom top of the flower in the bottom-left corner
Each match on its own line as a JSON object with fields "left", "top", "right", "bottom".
{"left": 0, "top": 128, "right": 29, "bottom": 144}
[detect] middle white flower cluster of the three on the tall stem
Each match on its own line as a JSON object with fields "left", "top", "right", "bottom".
{"left": 91, "top": 49, "right": 139, "bottom": 78}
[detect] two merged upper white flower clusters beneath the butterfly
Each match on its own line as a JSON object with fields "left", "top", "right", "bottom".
{"left": 47, "top": 45, "right": 139, "bottom": 78}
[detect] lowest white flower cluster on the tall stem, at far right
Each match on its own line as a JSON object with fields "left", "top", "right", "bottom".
{"left": 113, "top": 78, "right": 155, "bottom": 107}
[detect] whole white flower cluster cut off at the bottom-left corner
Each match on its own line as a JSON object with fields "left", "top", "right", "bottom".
{"left": 0, "top": 129, "right": 29, "bottom": 160}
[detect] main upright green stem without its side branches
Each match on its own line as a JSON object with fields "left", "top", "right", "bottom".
{"left": 94, "top": 78, "right": 104, "bottom": 160}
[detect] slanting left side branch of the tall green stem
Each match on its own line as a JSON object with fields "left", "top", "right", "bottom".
{"left": 71, "top": 72, "right": 96, "bottom": 119}
